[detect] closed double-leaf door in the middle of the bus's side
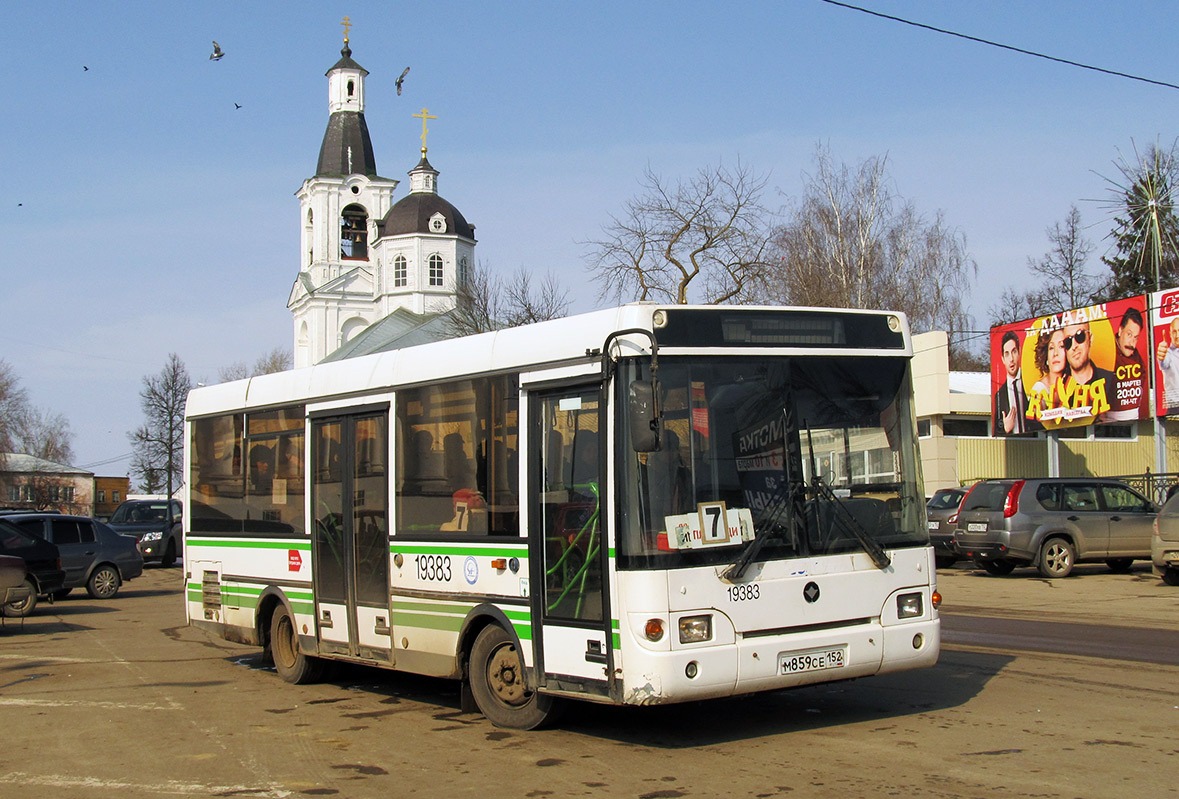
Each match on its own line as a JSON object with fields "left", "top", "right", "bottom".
{"left": 311, "top": 409, "right": 393, "bottom": 662}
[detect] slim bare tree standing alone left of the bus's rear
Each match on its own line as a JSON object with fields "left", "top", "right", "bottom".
{"left": 127, "top": 352, "right": 192, "bottom": 496}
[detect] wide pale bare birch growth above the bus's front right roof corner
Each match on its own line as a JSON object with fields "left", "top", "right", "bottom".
{"left": 757, "top": 146, "right": 977, "bottom": 361}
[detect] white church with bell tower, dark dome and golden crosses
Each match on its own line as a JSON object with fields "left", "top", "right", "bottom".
{"left": 286, "top": 37, "right": 475, "bottom": 368}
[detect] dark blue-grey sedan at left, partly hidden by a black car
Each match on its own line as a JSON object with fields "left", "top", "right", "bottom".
{"left": 5, "top": 513, "right": 144, "bottom": 599}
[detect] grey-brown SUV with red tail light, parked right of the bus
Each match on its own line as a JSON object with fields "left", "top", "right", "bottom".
{"left": 954, "top": 477, "right": 1158, "bottom": 577}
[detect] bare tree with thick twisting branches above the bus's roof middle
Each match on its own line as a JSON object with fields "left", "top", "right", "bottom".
{"left": 586, "top": 161, "right": 775, "bottom": 304}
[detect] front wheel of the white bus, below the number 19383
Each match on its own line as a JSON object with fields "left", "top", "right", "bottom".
{"left": 468, "top": 625, "right": 556, "bottom": 729}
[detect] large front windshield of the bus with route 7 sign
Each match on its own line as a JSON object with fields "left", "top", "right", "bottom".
{"left": 618, "top": 356, "right": 929, "bottom": 569}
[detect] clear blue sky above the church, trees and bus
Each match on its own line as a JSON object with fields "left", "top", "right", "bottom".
{"left": 0, "top": 0, "right": 1179, "bottom": 475}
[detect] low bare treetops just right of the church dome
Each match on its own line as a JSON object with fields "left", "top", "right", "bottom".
{"left": 446, "top": 263, "right": 571, "bottom": 336}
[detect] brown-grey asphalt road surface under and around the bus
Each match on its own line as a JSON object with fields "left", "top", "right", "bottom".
{"left": 0, "top": 560, "right": 1179, "bottom": 799}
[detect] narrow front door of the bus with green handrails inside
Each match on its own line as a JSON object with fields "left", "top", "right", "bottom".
{"left": 529, "top": 385, "right": 611, "bottom": 693}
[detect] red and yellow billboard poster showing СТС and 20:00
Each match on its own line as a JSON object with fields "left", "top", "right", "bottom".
{"left": 990, "top": 296, "right": 1145, "bottom": 436}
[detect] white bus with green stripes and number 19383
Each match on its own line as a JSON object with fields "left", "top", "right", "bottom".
{"left": 184, "top": 304, "right": 941, "bottom": 728}
